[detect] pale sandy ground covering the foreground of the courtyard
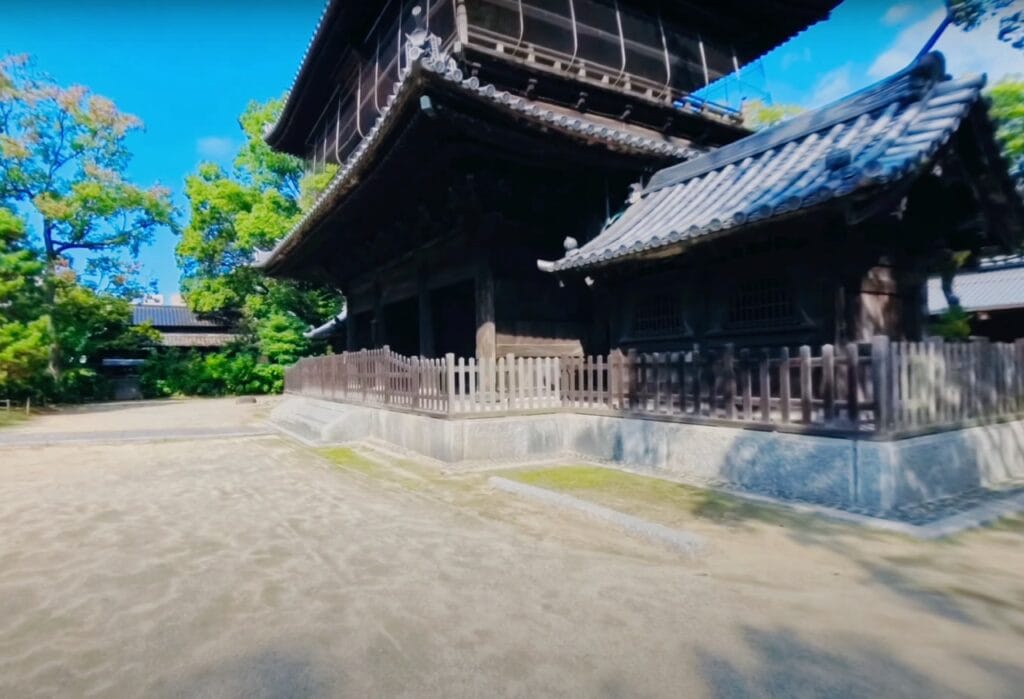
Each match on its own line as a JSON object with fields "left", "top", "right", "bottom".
{"left": 0, "top": 401, "right": 1024, "bottom": 697}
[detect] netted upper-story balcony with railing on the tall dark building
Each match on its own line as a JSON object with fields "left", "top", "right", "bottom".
{"left": 307, "top": 0, "right": 739, "bottom": 171}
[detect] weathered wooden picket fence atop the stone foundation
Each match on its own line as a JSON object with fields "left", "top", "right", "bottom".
{"left": 285, "top": 337, "right": 1024, "bottom": 434}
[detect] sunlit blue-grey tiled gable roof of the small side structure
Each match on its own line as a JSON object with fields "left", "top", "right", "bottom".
{"left": 539, "top": 53, "right": 985, "bottom": 271}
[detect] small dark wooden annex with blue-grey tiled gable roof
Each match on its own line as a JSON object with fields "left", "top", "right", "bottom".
{"left": 538, "top": 52, "right": 1022, "bottom": 347}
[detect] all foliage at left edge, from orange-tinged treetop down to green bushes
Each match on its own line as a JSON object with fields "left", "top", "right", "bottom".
{"left": 0, "top": 55, "right": 173, "bottom": 401}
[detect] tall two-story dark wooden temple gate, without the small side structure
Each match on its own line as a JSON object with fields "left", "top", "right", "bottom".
{"left": 257, "top": 0, "right": 838, "bottom": 357}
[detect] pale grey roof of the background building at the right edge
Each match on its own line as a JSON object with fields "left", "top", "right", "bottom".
{"left": 928, "top": 257, "right": 1024, "bottom": 315}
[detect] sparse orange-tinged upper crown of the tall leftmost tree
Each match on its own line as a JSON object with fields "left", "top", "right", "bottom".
{"left": 0, "top": 55, "right": 173, "bottom": 278}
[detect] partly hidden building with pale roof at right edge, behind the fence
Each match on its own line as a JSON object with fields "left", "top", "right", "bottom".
{"left": 928, "top": 255, "right": 1024, "bottom": 342}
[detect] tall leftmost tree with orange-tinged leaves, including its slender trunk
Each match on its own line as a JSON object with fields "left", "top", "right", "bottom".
{"left": 0, "top": 55, "right": 173, "bottom": 385}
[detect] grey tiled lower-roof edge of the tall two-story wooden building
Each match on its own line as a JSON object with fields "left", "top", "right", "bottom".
{"left": 253, "top": 36, "right": 700, "bottom": 274}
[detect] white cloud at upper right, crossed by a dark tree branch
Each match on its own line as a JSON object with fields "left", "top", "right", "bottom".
{"left": 867, "top": 9, "right": 1024, "bottom": 82}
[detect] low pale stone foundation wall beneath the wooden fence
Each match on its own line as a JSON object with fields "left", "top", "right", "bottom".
{"left": 272, "top": 396, "right": 1024, "bottom": 511}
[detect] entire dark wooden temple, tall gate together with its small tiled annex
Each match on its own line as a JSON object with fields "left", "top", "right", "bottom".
{"left": 257, "top": 0, "right": 1021, "bottom": 358}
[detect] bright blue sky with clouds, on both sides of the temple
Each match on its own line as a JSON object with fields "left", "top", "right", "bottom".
{"left": 0, "top": 0, "right": 1024, "bottom": 295}
